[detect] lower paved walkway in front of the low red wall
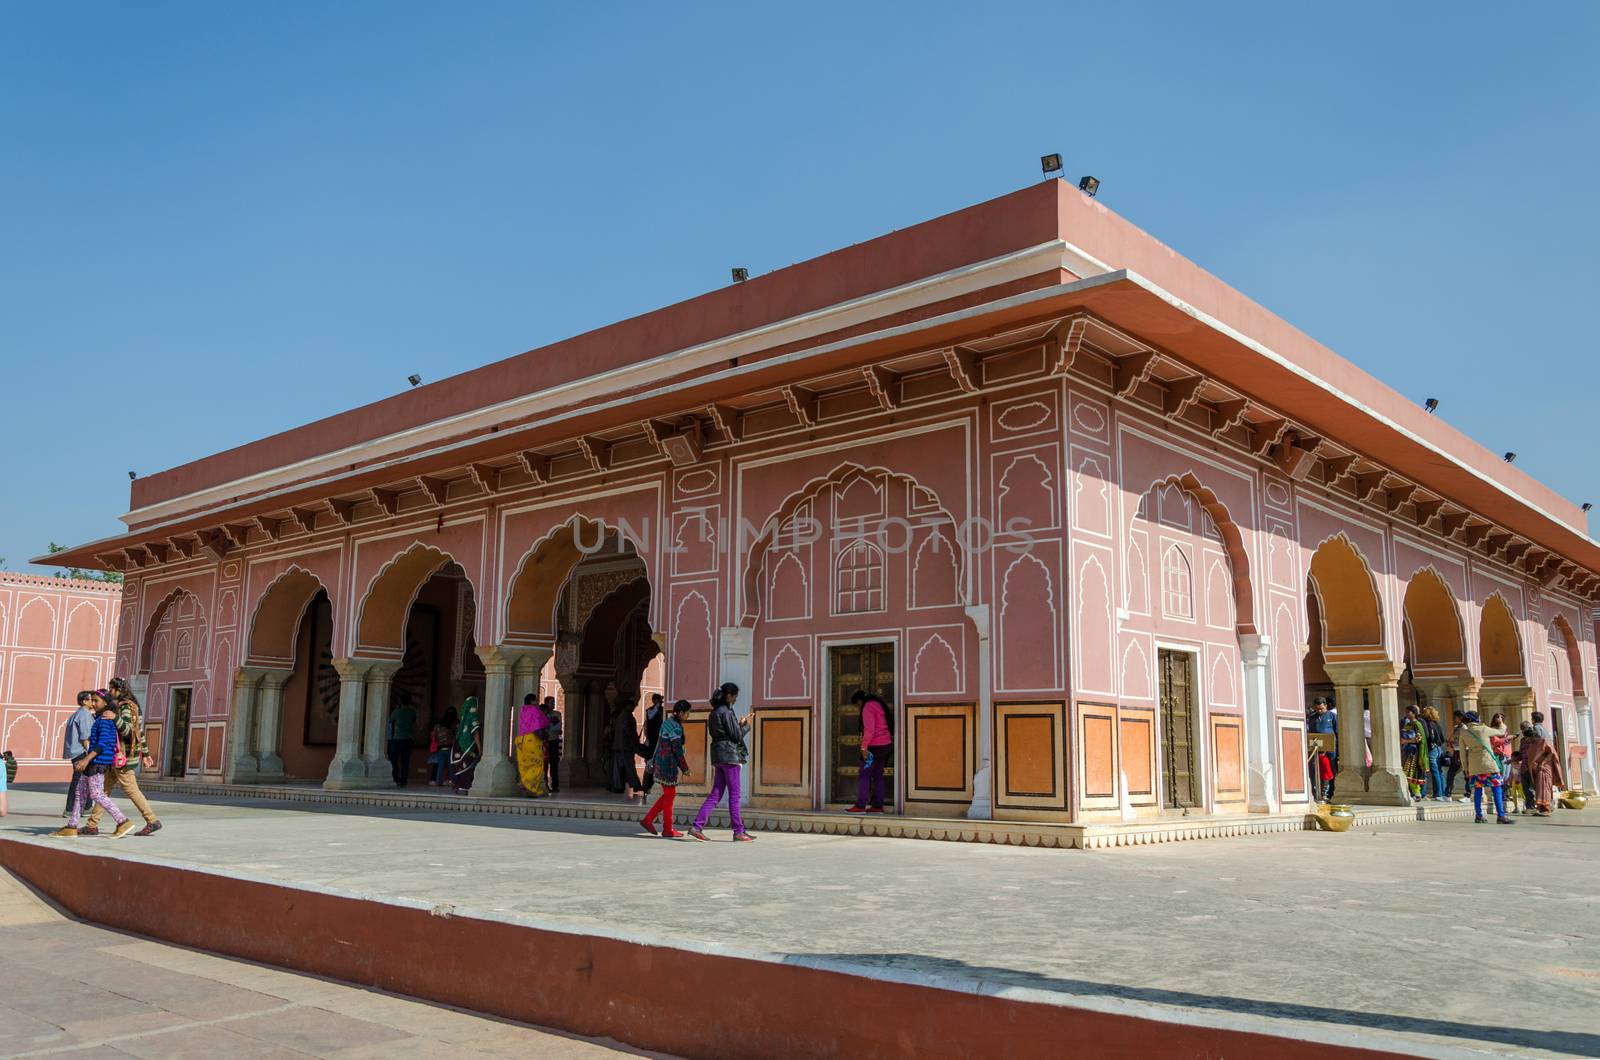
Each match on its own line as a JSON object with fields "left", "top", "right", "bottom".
{"left": 0, "top": 845, "right": 650, "bottom": 1060}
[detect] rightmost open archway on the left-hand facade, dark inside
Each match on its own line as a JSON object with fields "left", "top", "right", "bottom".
{"left": 501, "top": 517, "right": 666, "bottom": 794}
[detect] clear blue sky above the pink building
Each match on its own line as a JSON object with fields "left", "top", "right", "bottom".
{"left": 0, "top": 0, "right": 1600, "bottom": 568}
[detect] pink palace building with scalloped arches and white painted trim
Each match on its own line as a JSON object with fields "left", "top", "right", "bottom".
{"left": 48, "top": 181, "right": 1600, "bottom": 823}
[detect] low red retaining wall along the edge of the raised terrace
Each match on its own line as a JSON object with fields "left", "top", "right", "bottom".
{"left": 0, "top": 839, "right": 1394, "bottom": 1060}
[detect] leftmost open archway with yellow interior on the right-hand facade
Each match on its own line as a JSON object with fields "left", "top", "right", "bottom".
{"left": 1304, "top": 533, "right": 1411, "bottom": 805}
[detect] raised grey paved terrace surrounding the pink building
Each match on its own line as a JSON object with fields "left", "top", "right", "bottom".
{"left": 0, "top": 791, "right": 1600, "bottom": 1057}
